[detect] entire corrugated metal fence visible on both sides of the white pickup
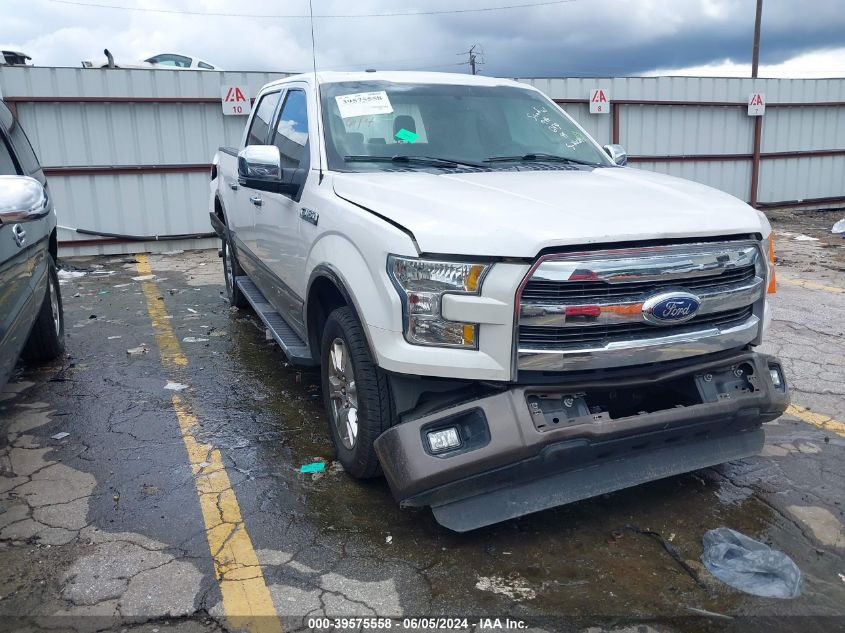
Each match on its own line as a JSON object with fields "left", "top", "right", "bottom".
{"left": 0, "top": 67, "right": 845, "bottom": 254}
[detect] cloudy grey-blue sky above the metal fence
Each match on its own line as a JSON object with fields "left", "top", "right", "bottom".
{"left": 0, "top": 0, "right": 845, "bottom": 78}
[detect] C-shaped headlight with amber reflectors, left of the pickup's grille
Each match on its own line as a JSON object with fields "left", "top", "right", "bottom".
{"left": 387, "top": 255, "right": 490, "bottom": 349}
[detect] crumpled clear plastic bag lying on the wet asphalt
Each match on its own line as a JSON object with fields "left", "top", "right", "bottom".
{"left": 701, "top": 528, "right": 801, "bottom": 598}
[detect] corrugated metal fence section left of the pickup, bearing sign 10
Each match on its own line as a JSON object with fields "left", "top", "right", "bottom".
{"left": 0, "top": 67, "right": 287, "bottom": 255}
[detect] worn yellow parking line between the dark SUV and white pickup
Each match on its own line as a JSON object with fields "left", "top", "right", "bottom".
{"left": 137, "top": 255, "right": 282, "bottom": 633}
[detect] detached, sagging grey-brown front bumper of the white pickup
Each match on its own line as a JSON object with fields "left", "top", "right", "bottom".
{"left": 375, "top": 352, "right": 789, "bottom": 532}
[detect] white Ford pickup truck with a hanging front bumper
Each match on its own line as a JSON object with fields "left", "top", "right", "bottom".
{"left": 210, "top": 72, "right": 788, "bottom": 531}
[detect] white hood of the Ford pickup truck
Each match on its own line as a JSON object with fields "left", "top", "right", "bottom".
{"left": 333, "top": 168, "right": 768, "bottom": 257}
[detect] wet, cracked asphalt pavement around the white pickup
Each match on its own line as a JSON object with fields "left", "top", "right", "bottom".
{"left": 0, "top": 212, "right": 845, "bottom": 633}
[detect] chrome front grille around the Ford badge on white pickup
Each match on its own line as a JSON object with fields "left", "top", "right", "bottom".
{"left": 516, "top": 241, "right": 767, "bottom": 371}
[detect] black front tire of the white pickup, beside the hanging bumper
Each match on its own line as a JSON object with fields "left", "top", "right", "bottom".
{"left": 320, "top": 306, "right": 395, "bottom": 479}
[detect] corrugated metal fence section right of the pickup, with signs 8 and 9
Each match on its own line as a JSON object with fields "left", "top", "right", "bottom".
{"left": 520, "top": 77, "right": 845, "bottom": 208}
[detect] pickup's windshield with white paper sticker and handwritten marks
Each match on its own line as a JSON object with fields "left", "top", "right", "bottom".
{"left": 320, "top": 81, "right": 612, "bottom": 171}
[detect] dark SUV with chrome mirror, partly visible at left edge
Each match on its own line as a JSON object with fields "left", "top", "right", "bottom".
{"left": 0, "top": 101, "right": 64, "bottom": 387}
